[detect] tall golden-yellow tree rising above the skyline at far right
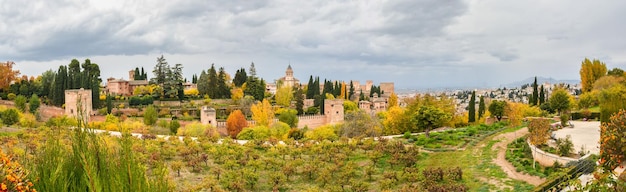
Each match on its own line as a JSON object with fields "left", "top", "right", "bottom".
{"left": 580, "top": 58, "right": 607, "bottom": 92}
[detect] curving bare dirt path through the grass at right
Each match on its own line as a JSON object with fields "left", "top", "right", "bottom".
{"left": 491, "top": 128, "right": 546, "bottom": 186}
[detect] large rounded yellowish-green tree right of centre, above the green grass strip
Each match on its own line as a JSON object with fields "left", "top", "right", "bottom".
{"left": 415, "top": 105, "right": 451, "bottom": 137}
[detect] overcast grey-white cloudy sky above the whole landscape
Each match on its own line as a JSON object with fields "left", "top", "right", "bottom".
{"left": 0, "top": 0, "right": 626, "bottom": 88}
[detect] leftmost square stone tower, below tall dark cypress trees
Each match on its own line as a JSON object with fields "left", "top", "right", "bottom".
{"left": 65, "top": 88, "right": 93, "bottom": 122}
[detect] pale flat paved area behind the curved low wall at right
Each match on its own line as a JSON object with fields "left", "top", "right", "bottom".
{"left": 553, "top": 121, "right": 600, "bottom": 154}
